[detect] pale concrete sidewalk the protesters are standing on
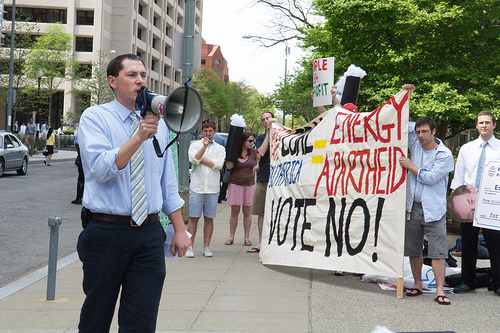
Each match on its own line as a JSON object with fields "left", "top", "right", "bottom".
{"left": 0, "top": 150, "right": 500, "bottom": 333}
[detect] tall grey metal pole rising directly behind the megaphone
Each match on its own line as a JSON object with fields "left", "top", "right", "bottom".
{"left": 179, "top": 0, "right": 196, "bottom": 222}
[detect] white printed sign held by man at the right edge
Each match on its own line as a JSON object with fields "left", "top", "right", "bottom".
{"left": 473, "top": 161, "right": 500, "bottom": 230}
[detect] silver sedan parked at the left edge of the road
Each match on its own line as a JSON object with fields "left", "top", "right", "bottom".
{"left": 0, "top": 131, "right": 29, "bottom": 177}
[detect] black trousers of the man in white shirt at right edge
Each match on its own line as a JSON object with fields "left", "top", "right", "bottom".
{"left": 461, "top": 223, "right": 500, "bottom": 290}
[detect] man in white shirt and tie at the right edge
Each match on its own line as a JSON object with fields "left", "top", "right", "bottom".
{"left": 450, "top": 111, "right": 500, "bottom": 295}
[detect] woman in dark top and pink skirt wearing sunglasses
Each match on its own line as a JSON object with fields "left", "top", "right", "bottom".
{"left": 225, "top": 131, "right": 260, "bottom": 246}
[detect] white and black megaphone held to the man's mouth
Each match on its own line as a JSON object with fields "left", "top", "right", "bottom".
{"left": 135, "top": 85, "right": 203, "bottom": 134}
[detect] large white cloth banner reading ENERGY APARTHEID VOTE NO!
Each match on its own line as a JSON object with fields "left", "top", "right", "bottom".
{"left": 260, "top": 90, "right": 409, "bottom": 277}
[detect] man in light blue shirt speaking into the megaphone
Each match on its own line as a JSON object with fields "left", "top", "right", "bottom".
{"left": 77, "top": 54, "right": 189, "bottom": 332}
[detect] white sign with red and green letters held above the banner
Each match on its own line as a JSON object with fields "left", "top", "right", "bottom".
{"left": 313, "top": 57, "right": 335, "bottom": 107}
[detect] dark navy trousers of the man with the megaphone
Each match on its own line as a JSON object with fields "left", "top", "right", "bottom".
{"left": 77, "top": 220, "right": 166, "bottom": 333}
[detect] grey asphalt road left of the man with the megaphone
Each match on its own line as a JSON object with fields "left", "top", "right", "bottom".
{"left": 0, "top": 162, "right": 81, "bottom": 287}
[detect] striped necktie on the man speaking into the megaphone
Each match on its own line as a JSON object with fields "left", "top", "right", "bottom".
{"left": 129, "top": 112, "right": 148, "bottom": 225}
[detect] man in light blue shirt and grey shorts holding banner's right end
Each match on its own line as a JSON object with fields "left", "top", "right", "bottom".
{"left": 399, "top": 85, "right": 454, "bottom": 305}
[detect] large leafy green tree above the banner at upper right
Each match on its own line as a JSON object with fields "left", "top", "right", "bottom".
{"left": 280, "top": 0, "right": 500, "bottom": 138}
